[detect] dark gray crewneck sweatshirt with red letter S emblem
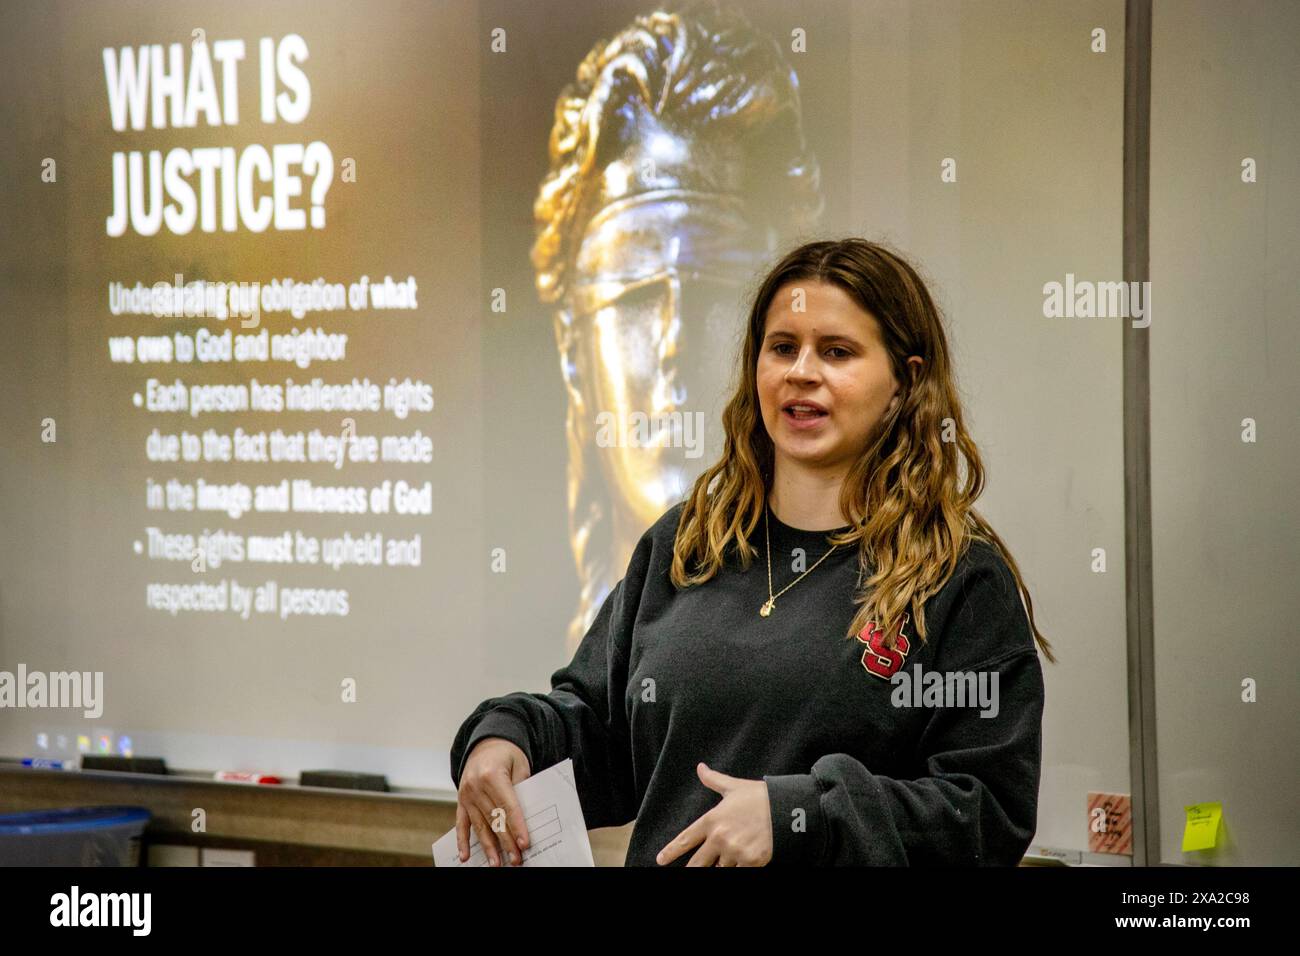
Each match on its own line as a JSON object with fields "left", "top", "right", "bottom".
{"left": 451, "top": 503, "right": 1043, "bottom": 866}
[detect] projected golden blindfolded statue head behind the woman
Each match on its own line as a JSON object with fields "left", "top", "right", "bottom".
{"left": 532, "top": 0, "right": 823, "bottom": 653}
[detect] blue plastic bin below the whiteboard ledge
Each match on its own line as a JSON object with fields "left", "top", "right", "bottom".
{"left": 0, "top": 806, "right": 150, "bottom": 866}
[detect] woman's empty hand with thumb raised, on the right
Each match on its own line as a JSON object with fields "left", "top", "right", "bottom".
{"left": 655, "top": 763, "right": 772, "bottom": 866}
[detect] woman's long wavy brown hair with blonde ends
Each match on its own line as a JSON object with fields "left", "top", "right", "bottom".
{"left": 671, "top": 238, "right": 1056, "bottom": 663}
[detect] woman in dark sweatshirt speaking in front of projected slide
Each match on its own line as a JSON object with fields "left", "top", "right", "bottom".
{"left": 451, "top": 238, "right": 1054, "bottom": 866}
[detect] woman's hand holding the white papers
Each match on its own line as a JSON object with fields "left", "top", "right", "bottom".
{"left": 456, "top": 737, "right": 532, "bottom": 866}
